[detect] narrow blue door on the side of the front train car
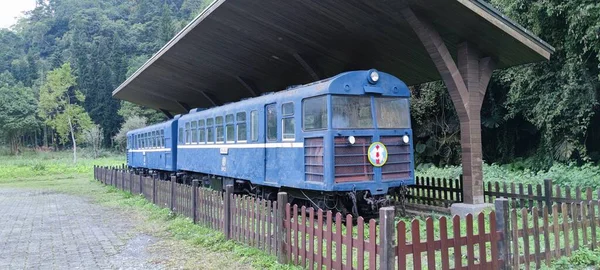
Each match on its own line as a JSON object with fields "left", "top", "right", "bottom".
{"left": 264, "top": 103, "right": 279, "bottom": 183}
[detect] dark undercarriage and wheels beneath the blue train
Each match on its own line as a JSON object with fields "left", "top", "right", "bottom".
{"left": 130, "top": 168, "right": 408, "bottom": 218}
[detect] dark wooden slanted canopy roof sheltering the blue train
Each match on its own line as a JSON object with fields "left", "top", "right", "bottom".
{"left": 113, "top": 0, "right": 554, "bottom": 113}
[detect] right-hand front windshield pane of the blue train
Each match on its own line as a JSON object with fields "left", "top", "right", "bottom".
{"left": 375, "top": 97, "right": 410, "bottom": 128}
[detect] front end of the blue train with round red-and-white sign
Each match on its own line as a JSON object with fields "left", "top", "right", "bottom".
{"left": 303, "top": 70, "right": 414, "bottom": 213}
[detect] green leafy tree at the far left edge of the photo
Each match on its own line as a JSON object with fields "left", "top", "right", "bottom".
{"left": 0, "top": 71, "right": 38, "bottom": 154}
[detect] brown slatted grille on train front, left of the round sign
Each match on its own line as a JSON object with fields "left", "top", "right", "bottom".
{"left": 334, "top": 136, "right": 373, "bottom": 183}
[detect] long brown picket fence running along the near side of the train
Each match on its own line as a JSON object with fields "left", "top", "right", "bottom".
{"left": 94, "top": 167, "right": 600, "bottom": 269}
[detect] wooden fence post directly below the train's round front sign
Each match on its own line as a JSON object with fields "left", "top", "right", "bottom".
{"left": 379, "top": 206, "right": 396, "bottom": 269}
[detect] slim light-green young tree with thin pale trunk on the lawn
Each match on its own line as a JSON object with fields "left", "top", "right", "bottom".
{"left": 38, "top": 63, "right": 92, "bottom": 163}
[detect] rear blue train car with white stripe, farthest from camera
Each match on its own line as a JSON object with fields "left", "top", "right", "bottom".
{"left": 127, "top": 115, "right": 179, "bottom": 175}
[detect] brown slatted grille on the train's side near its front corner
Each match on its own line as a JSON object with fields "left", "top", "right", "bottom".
{"left": 304, "top": 137, "right": 324, "bottom": 182}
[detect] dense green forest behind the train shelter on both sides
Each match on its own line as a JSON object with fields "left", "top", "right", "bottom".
{"left": 0, "top": 0, "right": 600, "bottom": 168}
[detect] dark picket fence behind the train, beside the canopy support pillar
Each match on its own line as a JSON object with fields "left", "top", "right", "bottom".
{"left": 406, "top": 177, "right": 600, "bottom": 213}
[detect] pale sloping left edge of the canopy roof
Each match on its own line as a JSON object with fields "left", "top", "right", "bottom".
{"left": 112, "top": 0, "right": 226, "bottom": 96}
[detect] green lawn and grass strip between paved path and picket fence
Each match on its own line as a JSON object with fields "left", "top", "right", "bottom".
{"left": 0, "top": 152, "right": 296, "bottom": 269}
